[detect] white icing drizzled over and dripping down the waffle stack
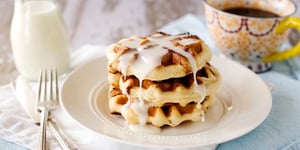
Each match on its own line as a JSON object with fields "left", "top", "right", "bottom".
{"left": 119, "top": 33, "right": 206, "bottom": 125}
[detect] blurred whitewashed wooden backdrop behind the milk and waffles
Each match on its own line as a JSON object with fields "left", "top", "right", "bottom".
{"left": 0, "top": 0, "right": 300, "bottom": 85}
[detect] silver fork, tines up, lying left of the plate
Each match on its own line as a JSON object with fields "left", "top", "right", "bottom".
{"left": 35, "top": 68, "right": 59, "bottom": 150}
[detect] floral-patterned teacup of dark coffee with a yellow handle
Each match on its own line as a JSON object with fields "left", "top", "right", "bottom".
{"left": 204, "top": 0, "right": 300, "bottom": 73}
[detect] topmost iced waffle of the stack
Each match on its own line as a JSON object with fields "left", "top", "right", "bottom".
{"left": 106, "top": 32, "right": 211, "bottom": 80}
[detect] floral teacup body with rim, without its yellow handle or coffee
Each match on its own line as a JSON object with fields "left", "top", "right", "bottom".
{"left": 204, "top": 0, "right": 296, "bottom": 72}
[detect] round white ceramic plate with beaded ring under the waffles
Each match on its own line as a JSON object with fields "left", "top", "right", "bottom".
{"left": 61, "top": 57, "right": 272, "bottom": 148}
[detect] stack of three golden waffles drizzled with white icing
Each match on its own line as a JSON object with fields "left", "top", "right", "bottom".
{"left": 106, "top": 32, "right": 220, "bottom": 127}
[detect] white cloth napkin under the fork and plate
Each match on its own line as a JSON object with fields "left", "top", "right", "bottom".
{"left": 0, "top": 45, "right": 216, "bottom": 150}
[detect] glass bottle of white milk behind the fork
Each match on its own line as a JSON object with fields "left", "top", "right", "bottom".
{"left": 10, "top": 0, "right": 70, "bottom": 80}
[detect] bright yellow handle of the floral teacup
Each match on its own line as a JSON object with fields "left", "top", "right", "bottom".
{"left": 263, "top": 17, "right": 300, "bottom": 62}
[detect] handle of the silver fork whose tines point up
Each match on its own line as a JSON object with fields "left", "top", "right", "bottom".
{"left": 38, "top": 109, "right": 48, "bottom": 150}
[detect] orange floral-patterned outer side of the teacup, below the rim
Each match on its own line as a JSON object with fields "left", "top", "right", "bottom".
{"left": 208, "top": 12, "right": 288, "bottom": 61}
